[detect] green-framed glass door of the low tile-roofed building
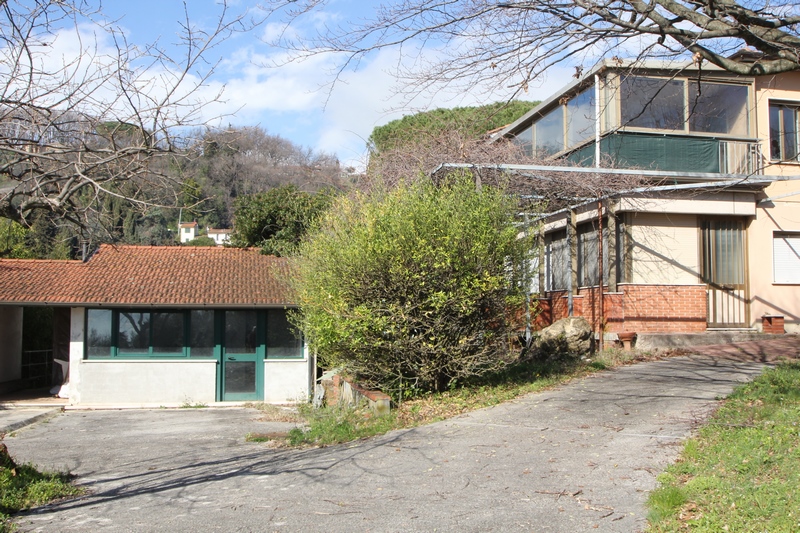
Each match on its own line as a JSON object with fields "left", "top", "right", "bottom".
{"left": 220, "top": 310, "right": 264, "bottom": 401}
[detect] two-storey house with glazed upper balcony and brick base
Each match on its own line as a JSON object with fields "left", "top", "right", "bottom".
{"left": 496, "top": 61, "right": 800, "bottom": 333}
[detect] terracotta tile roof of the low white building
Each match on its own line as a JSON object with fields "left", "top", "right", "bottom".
{"left": 0, "top": 245, "right": 293, "bottom": 307}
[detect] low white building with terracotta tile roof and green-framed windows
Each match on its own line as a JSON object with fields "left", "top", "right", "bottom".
{"left": 0, "top": 245, "right": 315, "bottom": 406}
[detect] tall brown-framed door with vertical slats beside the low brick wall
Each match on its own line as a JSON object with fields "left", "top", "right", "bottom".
{"left": 701, "top": 219, "right": 750, "bottom": 328}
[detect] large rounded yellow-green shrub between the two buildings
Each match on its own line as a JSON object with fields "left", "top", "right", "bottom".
{"left": 294, "top": 176, "right": 529, "bottom": 398}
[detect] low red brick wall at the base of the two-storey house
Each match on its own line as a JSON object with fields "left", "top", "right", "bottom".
{"left": 534, "top": 284, "right": 707, "bottom": 333}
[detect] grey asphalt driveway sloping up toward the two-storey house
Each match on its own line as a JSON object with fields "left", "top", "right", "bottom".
{"left": 6, "top": 339, "right": 797, "bottom": 533}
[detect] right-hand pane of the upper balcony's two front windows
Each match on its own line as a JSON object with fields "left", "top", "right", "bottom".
{"left": 689, "top": 82, "right": 748, "bottom": 136}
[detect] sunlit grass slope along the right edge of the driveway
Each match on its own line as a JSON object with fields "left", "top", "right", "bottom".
{"left": 648, "top": 362, "right": 800, "bottom": 533}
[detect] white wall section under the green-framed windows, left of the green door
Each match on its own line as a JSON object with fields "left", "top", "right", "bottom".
{"left": 80, "top": 359, "right": 217, "bottom": 406}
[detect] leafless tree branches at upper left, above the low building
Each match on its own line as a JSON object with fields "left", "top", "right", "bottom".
{"left": 0, "top": 0, "right": 258, "bottom": 223}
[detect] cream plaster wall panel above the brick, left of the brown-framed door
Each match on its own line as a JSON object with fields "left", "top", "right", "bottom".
{"left": 629, "top": 213, "right": 700, "bottom": 285}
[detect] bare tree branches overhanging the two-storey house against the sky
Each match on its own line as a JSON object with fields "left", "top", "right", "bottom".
{"left": 263, "top": 0, "right": 800, "bottom": 101}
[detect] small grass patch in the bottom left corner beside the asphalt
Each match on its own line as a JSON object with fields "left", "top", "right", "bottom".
{"left": 0, "top": 446, "right": 83, "bottom": 533}
